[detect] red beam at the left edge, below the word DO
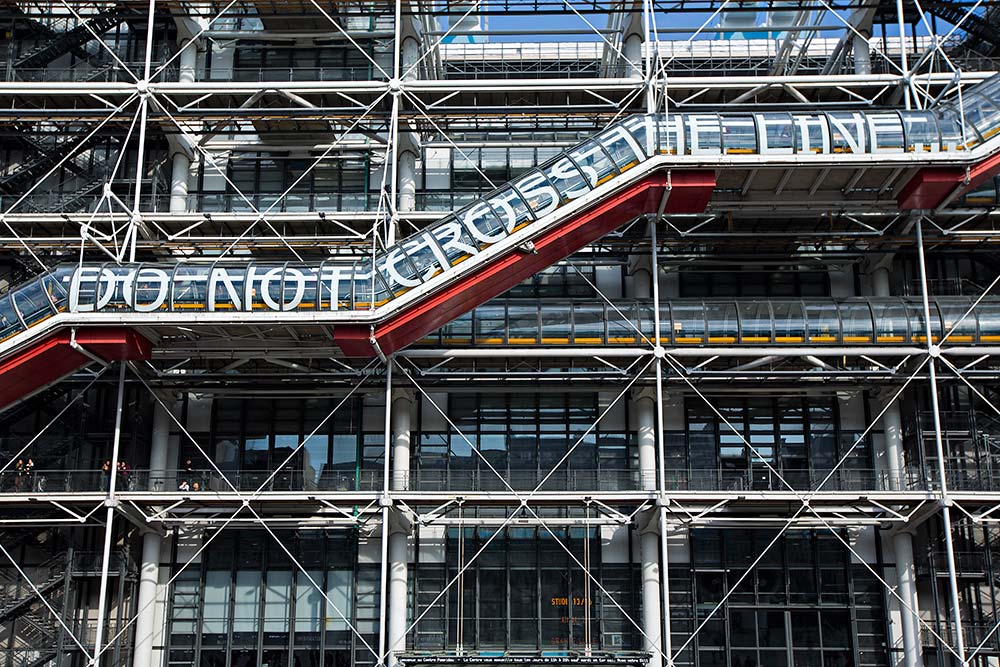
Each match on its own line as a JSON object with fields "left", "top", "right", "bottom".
{"left": 0, "top": 327, "right": 152, "bottom": 409}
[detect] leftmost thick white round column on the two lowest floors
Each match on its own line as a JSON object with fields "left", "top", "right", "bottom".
{"left": 132, "top": 402, "right": 172, "bottom": 667}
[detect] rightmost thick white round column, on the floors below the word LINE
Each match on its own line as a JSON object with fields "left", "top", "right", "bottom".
{"left": 871, "top": 266, "right": 923, "bottom": 667}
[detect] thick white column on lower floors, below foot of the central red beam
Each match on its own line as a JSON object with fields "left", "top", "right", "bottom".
{"left": 386, "top": 389, "right": 413, "bottom": 667}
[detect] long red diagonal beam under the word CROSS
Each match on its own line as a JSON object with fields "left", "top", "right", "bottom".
{"left": 334, "top": 170, "right": 715, "bottom": 357}
